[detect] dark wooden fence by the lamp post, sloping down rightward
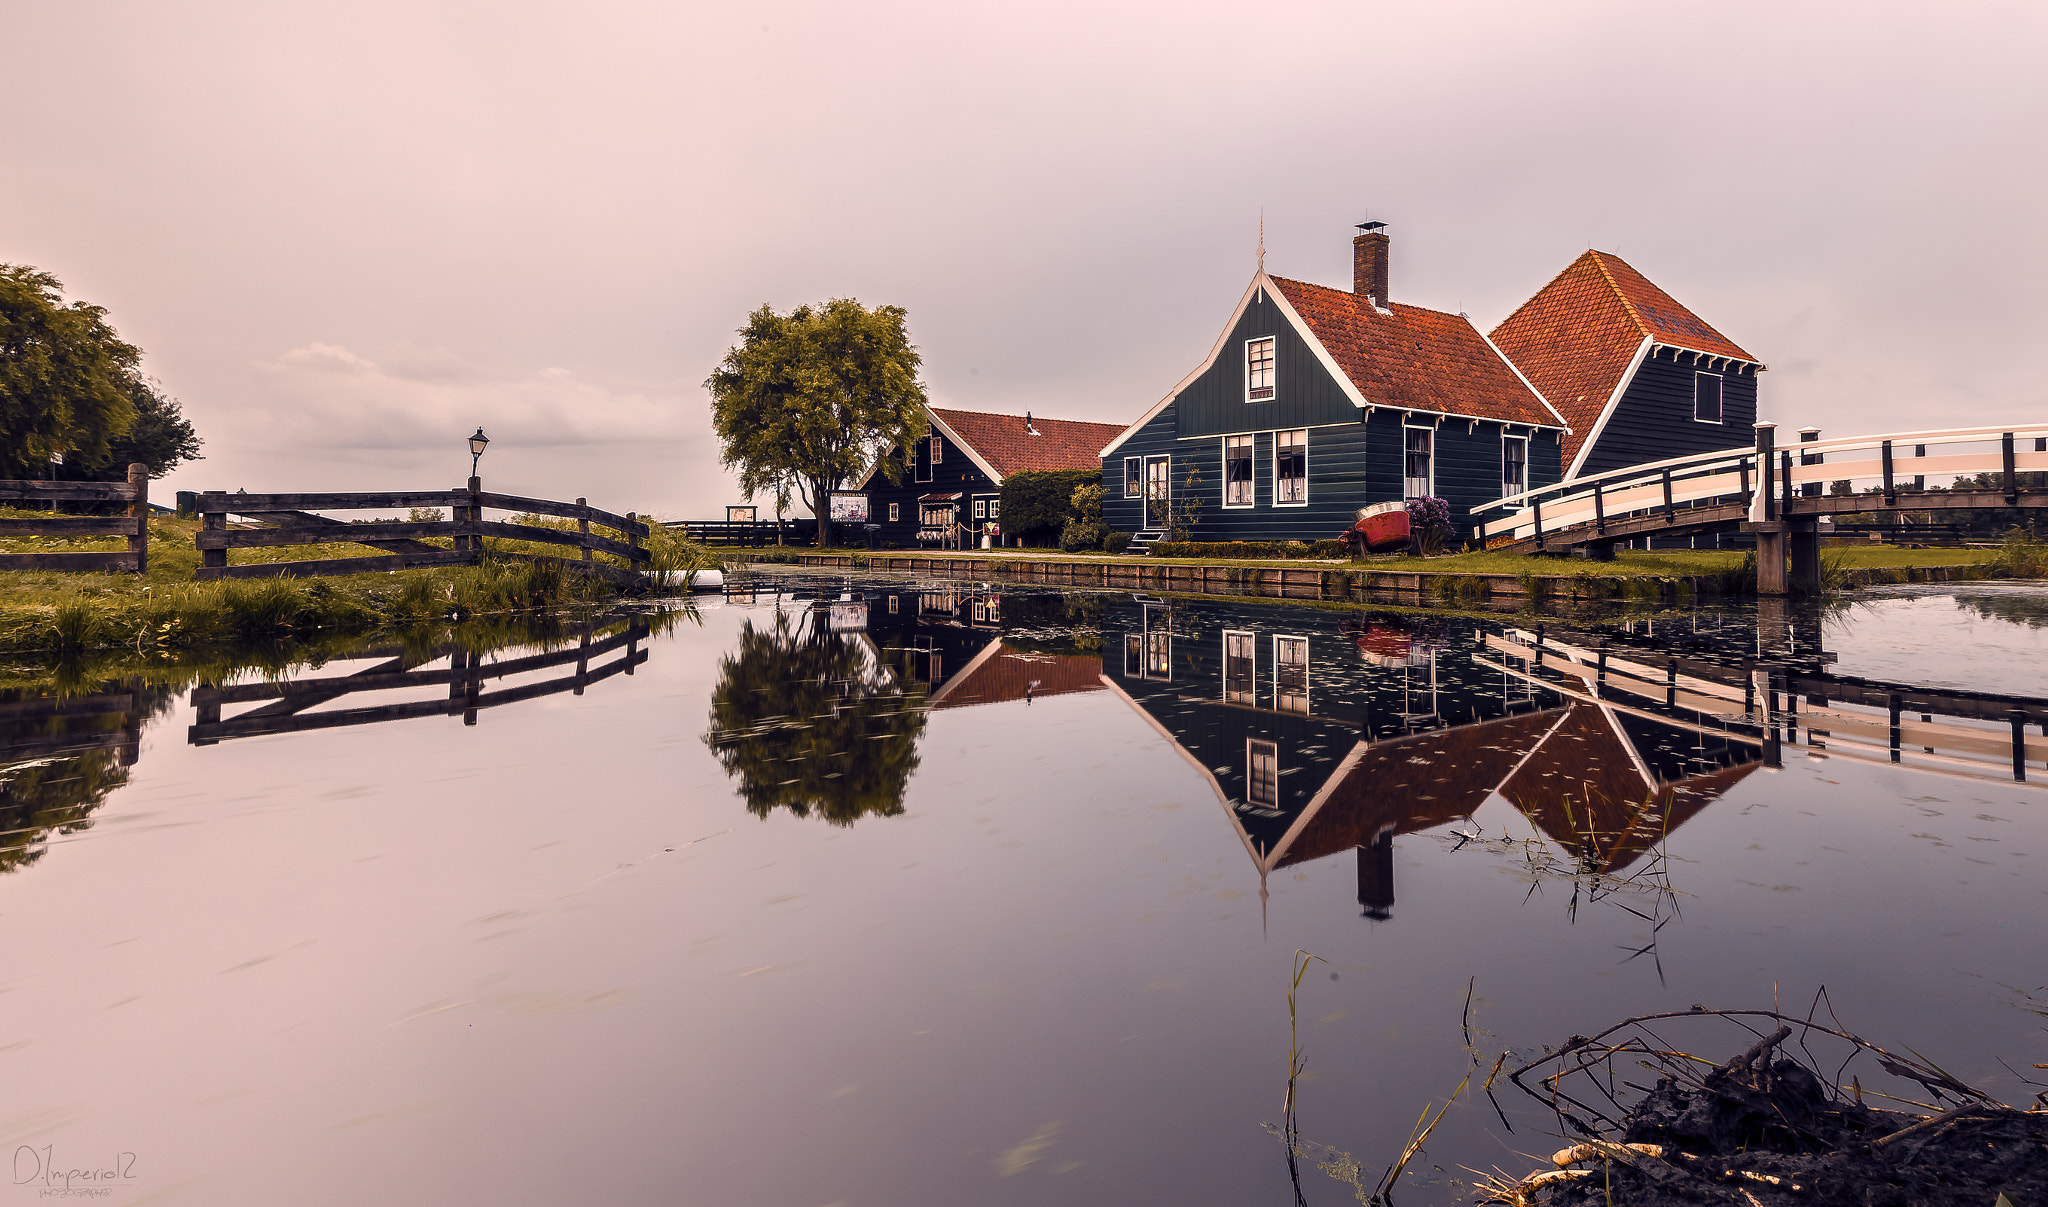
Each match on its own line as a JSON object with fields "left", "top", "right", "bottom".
{"left": 195, "top": 477, "right": 653, "bottom": 588}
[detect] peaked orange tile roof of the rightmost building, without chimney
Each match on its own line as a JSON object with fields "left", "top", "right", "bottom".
{"left": 1493, "top": 252, "right": 1757, "bottom": 469}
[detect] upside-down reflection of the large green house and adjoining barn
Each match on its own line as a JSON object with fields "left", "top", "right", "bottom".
{"left": 1104, "top": 600, "right": 1759, "bottom": 918}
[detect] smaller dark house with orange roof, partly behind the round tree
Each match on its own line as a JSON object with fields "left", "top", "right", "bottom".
{"left": 854, "top": 408, "right": 1122, "bottom": 547}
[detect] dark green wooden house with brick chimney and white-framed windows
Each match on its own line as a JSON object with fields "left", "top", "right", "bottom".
{"left": 1102, "top": 232, "right": 1567, "bottom": 541}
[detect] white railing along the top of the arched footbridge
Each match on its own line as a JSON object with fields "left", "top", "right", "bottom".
{"left": 1473, "top": 424, "right": 2048, "bottom": 543}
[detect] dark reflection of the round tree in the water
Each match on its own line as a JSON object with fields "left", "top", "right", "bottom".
{"left": 705, "top": 613, "right": 924, "bottom": 826}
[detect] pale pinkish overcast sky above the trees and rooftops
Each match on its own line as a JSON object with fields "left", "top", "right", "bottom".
{"left": 0, "top": 0, "right": 2048, "bottom": 516}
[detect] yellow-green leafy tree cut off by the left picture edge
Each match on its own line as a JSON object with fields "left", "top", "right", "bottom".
{"left": 0, "top": 264, "right": 141, "bottom": 477}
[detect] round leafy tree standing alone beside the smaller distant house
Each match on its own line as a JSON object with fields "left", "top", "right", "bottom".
{"left": 705, "top": 297, "right": 930, "bottom": 545}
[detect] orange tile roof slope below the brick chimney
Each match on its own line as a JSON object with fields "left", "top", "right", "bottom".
{"left": 1270, "top": 277, "right": 1559, "bottom": 426}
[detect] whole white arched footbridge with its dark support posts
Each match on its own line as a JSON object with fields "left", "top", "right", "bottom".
{"left": 1473, "top": 424, "right": 2048, "bottom": 594}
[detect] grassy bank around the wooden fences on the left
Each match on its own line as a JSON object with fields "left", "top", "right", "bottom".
{"left": 0, "top": 512, "right": 719, "bottom": 658}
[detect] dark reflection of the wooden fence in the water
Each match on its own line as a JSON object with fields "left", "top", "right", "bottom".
{"left": 188, "top": 623, "right": 647, "bottom": 746}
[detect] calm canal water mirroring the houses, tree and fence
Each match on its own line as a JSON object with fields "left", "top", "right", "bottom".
{"left": 0, "top": 576, "right": 2048, "bottom": 1207}
